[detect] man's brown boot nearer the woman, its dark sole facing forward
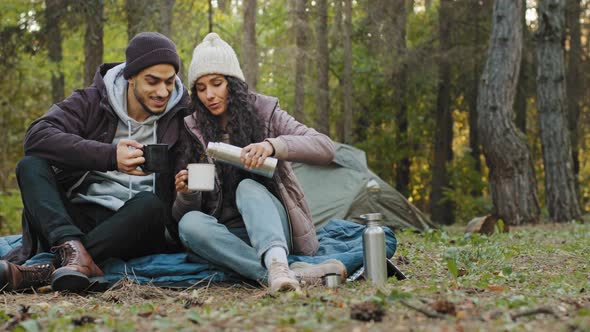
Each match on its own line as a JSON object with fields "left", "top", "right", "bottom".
{"left": 51, "top": 240, "right": 103, "bottom": 292}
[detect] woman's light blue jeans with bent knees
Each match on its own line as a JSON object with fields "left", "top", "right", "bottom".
{"left": 178, "top": 179, "right": 291, "bottom": 281}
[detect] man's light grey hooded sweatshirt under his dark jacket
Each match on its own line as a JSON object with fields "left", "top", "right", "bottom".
{"left": 72, "top": 63, "right": 183, "bottom": 211}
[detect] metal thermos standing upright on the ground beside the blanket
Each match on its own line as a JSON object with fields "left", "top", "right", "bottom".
{"left": 361, "top": 213, "right": 387, "bottom": 285}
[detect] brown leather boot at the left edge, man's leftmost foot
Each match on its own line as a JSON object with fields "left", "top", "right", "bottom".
{"left": 0, "top": 260, "right": 55, "bottom": 292}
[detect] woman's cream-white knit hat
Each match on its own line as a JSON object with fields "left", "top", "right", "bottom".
{"left": 188, "top": 32, "right": 246, "bottom": 89}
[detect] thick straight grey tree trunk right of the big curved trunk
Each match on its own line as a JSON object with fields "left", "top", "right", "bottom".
{"left": 537, "top": 0, "right": 581, "bottom": 222}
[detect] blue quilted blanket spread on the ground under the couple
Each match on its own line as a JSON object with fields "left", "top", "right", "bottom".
{"left": 0, "top": 219, "right": 397, "bottom": 287}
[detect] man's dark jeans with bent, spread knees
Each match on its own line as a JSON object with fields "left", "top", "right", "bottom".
{"left": 17, "top": 156, "right": 168, "bottom": 263}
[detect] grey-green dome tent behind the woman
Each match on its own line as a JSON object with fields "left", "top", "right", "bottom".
{"left": 293, "top": 143, "right": 436, "bottom": 231}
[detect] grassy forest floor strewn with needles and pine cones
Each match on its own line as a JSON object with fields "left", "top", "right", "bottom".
{"left": 0, "top": 219, "right": 590, "bottom": 331}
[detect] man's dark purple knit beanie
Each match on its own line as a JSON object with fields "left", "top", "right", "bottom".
{"left": 123, "top": 32, "right": 180, "bottom": 79}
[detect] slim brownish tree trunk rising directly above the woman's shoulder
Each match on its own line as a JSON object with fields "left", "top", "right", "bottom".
{"left": 294, "top": 0, "right": 307, "bottom": 123}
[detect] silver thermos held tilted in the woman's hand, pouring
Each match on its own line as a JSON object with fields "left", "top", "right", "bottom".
{"left": 207, "top": 142, "right": 278, "bottom": 178}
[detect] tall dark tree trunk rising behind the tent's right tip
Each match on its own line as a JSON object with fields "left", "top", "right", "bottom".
{"left": 430, "top": 0, "right": 454, "bottom": 225}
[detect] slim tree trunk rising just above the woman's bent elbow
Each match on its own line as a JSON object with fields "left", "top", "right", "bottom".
{"left": 316, "top": 0, "right": 330, "bottom": 134}
